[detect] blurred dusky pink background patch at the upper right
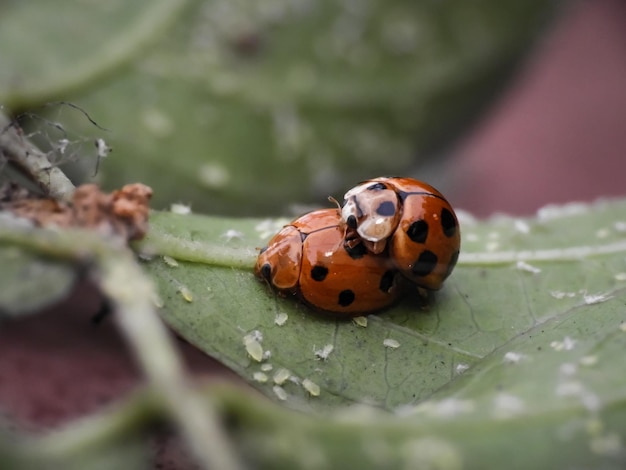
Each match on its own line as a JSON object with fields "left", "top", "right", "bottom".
{"left": 446, "top": 0, "right": 626, "bottom": 216}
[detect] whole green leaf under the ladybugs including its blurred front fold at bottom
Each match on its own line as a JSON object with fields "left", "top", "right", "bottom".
{"left": 140, "top": 201, "right": 626, "bottom": 469}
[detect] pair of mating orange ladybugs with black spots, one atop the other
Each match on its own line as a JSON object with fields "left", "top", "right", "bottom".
{"left": 255, "top": 177, "right": 461, "bottom": 316}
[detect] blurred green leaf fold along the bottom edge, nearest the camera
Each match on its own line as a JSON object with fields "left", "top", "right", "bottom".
{"left": 211, "top": 378, "right": 626, "bottom": 470}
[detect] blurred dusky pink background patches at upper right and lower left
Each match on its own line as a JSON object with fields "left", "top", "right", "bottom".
{"left": 0, "top": 0, "right": 626, "bottom": 468}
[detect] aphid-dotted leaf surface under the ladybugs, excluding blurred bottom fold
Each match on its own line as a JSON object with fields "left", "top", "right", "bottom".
{"left": 141, "top": 198, "right": 626, "bottom": 416}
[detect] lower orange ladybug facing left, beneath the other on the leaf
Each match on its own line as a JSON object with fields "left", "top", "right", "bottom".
{"left": 254, "top": 209, "right": 402, "bottom": 316}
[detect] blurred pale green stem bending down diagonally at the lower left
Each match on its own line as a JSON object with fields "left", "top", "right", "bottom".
{"left": 0, "top": 219, "right": 240, "bottom": 470}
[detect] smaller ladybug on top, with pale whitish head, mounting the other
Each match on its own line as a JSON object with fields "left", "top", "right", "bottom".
{"left": 341, "top": 177, "right": 461, "bottom": 290}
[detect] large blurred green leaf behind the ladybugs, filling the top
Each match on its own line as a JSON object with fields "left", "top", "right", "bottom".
{"left": 0, "top": 0, "right": 561, "bottom": 216}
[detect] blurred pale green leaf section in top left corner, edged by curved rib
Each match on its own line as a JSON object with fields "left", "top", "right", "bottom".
{"left": 0, "top": 0, "right": 187, "bottom": 107}
